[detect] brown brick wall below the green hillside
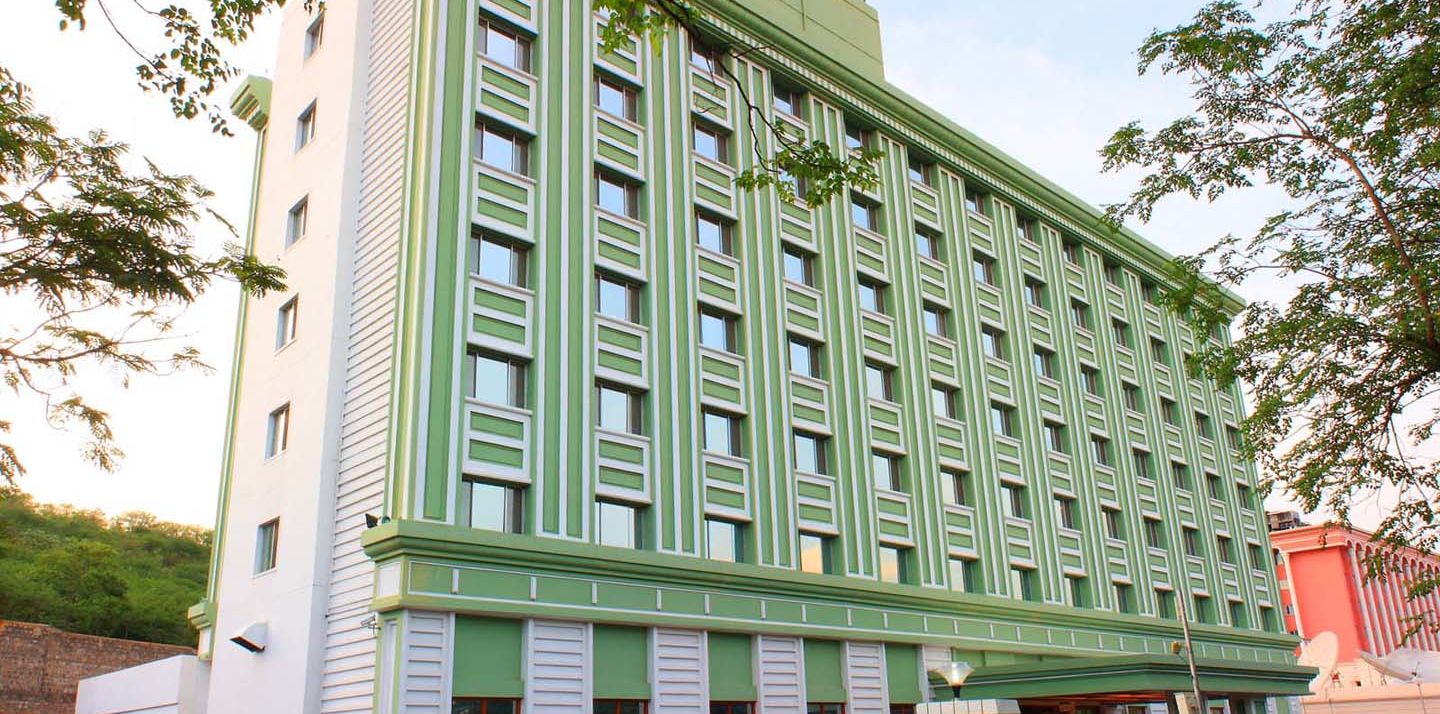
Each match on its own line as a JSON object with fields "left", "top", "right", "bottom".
{"left": 0, "top": 620, "right": 194, "bottom": 714}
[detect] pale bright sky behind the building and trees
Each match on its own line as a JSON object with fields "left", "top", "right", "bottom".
{"left": 0, "top": 0, "right": 1378, "bottom": 525}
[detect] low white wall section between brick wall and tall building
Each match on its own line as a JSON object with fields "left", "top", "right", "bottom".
{"left": 75, "top": 655, "right": 210, "bottom": 714}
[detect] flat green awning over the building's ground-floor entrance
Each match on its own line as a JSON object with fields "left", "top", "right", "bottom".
{"left": 960, "top": 655, "right": 1315, "bottom": 702}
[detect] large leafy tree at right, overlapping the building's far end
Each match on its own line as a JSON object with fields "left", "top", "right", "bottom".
{"left": 1102, "top": 0, "right": 1440, "bottom": 636}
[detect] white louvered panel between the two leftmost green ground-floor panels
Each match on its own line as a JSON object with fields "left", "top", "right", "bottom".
{"left": 526, "top": 620, "right": 590, "bottom": 714}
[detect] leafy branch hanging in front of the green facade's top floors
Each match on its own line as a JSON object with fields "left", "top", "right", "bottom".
{"left": 595, "top": 0, "right": 881, "bottom": 206}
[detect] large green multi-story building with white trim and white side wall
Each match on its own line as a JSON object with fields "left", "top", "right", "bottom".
{"left": 135, "top": 0, "right": 1308, "bottom": 714}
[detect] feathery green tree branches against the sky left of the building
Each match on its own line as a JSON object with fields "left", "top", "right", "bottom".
{"left": 0, "top": 0, "right": 303, "bottom": 482}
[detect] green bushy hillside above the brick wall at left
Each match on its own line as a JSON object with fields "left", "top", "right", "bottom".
{"left": 0, "top": 487, "right": 210, "bottom": 646}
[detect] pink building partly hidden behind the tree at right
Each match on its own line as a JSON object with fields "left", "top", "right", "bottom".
{"left": 1270, "top": 521, "right": 1440, "bottom": 662}
